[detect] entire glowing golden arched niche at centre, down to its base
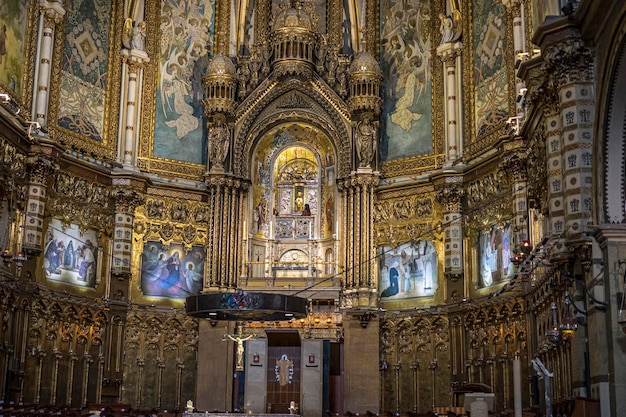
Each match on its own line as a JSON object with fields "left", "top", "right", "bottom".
{"left": 245, "top": 121, "right": 338, "bottom": 287}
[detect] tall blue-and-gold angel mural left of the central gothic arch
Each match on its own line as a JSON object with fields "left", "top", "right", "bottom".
{"left": 154, "top": 0, "right": 215, "bottom": 164}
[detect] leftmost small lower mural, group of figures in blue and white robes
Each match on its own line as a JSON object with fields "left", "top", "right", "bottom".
{"left": 43, "top": 219, "right": 100, "bottom": 288}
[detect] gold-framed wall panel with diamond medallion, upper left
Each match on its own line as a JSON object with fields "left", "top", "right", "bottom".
{"left": 48, "top": 0, "right": 122, "bottom": 161}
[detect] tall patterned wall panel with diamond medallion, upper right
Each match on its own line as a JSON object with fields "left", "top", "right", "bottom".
{"left": 473, "top": 0, "right": 509, "bottom": 136}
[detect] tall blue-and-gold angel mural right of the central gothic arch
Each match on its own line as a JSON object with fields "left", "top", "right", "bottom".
{"left": 380, "top": 0, "right": 433, "bottom": 160}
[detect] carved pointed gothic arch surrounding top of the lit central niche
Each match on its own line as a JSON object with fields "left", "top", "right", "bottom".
{"left": 233, "top": 78, "right": 353, "bottom": 178}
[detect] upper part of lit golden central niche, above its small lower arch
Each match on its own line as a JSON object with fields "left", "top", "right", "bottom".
{"left": 249, "top": 122, "right": 337, "bottom": 240}
